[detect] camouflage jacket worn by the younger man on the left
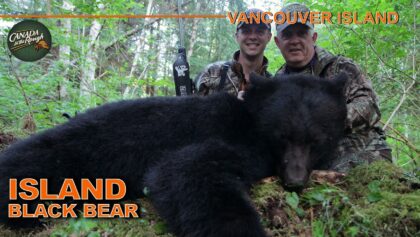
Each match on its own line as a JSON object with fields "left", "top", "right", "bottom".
{"left": 195, "top": 50, "right": 271, "bottom": 96}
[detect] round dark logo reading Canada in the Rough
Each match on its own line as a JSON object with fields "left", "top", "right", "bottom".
{"left": 7, "top": 20, "right": 51, "bottom": 62}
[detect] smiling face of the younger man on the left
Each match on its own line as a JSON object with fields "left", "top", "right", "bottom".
{"left": 235, "top": 24, "right": 271, "bottom": 58}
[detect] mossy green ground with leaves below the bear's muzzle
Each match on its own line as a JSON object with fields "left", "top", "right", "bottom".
{"left": 253, "top": 161, "right": 420, "bottom": 236}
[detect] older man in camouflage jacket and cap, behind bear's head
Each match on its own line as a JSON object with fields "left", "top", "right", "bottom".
{"left": 274, "top": 3, "right": 391, "bottom": 172}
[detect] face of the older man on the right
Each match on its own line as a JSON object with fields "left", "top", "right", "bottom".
{"left": 274, "top": 24, "right": 317, "bottom": 68}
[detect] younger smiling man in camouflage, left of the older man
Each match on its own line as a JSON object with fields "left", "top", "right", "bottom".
{"left": 196, "top": 9, "right": 271, "bottom": 95}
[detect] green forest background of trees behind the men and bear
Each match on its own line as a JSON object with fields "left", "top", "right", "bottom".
{"left": 0, "top": 0, "right": 420, "bottom": 171}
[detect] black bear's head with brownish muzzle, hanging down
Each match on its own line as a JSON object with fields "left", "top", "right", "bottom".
{"left": 244, "top": 74, "right": 347, "bottom": 191}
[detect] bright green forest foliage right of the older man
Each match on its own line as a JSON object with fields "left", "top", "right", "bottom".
{"left": 296, "top": 0, "right": 420, "bottom": 170}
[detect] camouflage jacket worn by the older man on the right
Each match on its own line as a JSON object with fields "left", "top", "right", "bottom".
{"left": 276, "top": 46, "right": 391, "bottom": 168}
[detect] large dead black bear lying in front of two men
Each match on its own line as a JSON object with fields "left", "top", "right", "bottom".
{"left": 0, "top": 75, "right": 346, "bottom": 237}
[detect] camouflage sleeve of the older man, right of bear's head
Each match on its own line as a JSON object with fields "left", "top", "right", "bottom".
{"left": 335, "top": 58, "right": 381, "bottom": 131}
